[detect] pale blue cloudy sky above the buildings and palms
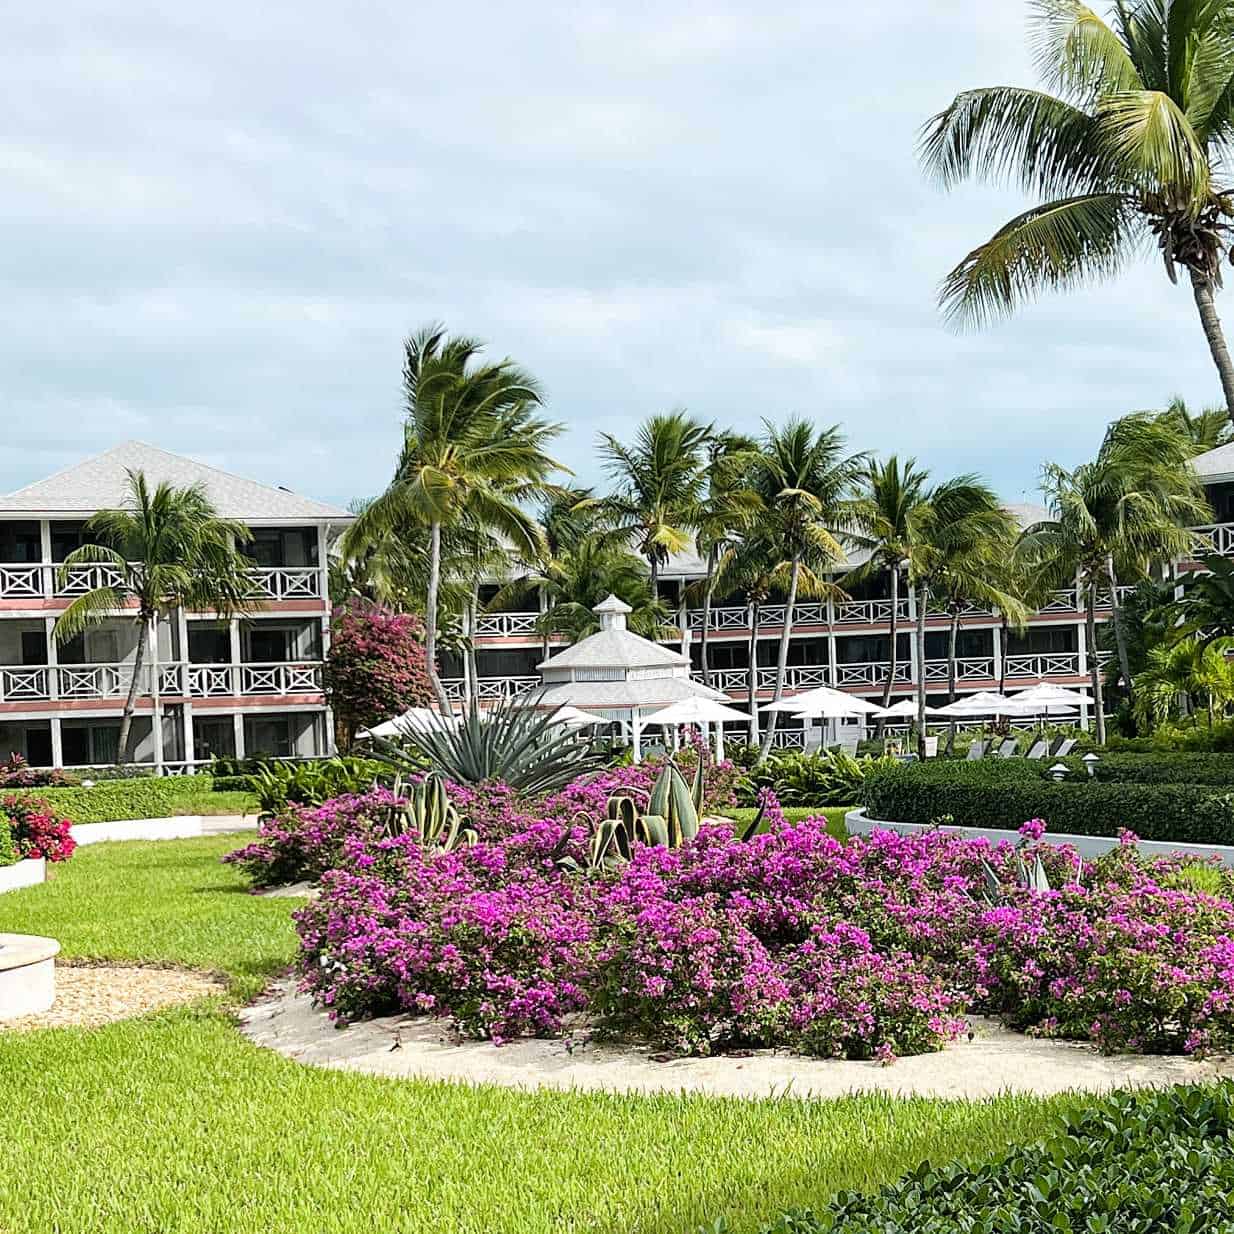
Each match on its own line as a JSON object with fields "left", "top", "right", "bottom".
{"left": 0, "top": 0, "right": 1234, "bottom": 503}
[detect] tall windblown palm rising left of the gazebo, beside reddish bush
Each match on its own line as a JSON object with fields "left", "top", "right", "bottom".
{"left": 342, "top": 326, "right": 563, "bottom": 711}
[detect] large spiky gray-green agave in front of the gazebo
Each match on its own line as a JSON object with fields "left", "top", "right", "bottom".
{"left": 374, "top": 698, "right": 603, "bottom": 795}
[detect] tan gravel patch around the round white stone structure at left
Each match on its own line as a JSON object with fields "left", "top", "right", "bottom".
{"left": 0, "top": 964, "right": 226, "bottom": 1033}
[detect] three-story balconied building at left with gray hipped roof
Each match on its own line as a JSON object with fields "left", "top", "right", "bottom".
{"left": 0, "top": 442, "right": 350, "bottom": 771}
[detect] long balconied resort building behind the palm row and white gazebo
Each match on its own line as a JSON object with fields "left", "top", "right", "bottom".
{"left": 454, "top": 445, "right": 1234, "bottom": 747}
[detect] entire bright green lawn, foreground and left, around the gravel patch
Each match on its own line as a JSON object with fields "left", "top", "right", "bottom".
{"left": 0, "top": 838, "right": 1062, "bottom": 1234}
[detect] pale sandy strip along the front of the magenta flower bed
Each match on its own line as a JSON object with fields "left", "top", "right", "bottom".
{"left": 241, "top": 982, "right": 1234, "bottom": 1098}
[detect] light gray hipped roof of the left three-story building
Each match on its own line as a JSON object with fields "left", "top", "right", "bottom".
{"left": 0, "top": 442, "right": 353, "bottom": 523}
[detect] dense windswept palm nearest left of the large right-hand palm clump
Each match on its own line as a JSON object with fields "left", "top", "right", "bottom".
{"left": 906, "top": 475, "right": 1023, "bottom": 758}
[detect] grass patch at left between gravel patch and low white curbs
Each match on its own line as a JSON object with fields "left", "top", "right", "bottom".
{"left": 0, "top": 835, "right": 296, "bottom": 997}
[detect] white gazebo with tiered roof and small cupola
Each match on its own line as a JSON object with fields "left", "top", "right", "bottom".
{"left": 528, "top": 596, "right": 728, "bottom": 761}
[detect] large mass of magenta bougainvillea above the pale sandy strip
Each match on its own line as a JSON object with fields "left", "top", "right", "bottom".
{"left": 293, "top": 789, "right": 1234, "bottom": 1061}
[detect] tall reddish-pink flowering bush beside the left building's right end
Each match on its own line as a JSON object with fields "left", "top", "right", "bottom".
{"left": 322, "top": 600, "right": 433, "bottom": 744}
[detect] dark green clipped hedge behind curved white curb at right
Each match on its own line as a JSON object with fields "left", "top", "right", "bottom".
{"left": 861, "top": 760, "right": 1234, "bottom": 844}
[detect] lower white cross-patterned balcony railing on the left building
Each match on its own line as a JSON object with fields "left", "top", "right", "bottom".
{"left": 0, "top": 661, "right": 322, "bottom": 703}
